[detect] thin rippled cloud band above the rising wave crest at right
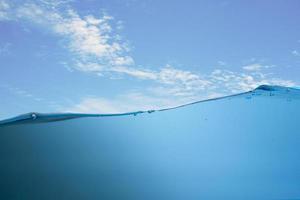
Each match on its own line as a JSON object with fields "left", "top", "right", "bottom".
{"left": 112, "top": 65, "right": 296, "bottom": 96}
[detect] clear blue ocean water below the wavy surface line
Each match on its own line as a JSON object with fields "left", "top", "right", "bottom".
{"left": 0, "top": 86, "right": 300, "bottom": 200}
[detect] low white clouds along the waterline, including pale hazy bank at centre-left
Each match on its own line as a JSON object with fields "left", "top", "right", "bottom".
{"left": 67, "top": 66, "right": 296, "bottom": 113}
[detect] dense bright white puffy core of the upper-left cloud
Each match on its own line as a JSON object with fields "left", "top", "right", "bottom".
{"left": 54, "top": 11, "right": 118, "bottom": 58}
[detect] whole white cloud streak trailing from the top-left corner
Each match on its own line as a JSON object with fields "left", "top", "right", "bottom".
{"left": 0, "top": 0, "right": 134, "bottom": 73}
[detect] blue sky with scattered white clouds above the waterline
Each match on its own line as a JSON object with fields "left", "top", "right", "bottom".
{"left": 0, "top": 0, "right": 300, "bottom": 119}
